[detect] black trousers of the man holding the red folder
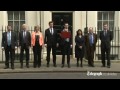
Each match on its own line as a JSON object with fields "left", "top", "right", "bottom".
{"left": 62, "top": 42, "right": 71, "bottom": 64}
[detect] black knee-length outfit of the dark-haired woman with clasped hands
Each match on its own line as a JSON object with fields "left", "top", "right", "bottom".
{"left": 75, "top": 36, "right": 85, "bottom": 58}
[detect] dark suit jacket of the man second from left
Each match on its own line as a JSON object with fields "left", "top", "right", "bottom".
{"left": 19, "top": 31, "right": 31, "bottom": 46}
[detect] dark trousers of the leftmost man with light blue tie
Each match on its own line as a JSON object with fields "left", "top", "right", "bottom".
{"left": 5, "top": 46, "right": 15, "bottom": 67}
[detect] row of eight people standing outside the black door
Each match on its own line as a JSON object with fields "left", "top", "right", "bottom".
{"left": 2, "top": 21, "right": 113, "bottom": 69}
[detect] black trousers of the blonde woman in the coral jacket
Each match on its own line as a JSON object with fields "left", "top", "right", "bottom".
{"left": 33, "top": 45, "right": 42, "bottom": 67}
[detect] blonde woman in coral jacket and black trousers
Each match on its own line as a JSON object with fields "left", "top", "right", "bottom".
{"left": 31, "top": 25, "right": 44, "bottom": 68}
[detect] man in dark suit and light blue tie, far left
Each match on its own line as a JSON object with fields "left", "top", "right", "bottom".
{"left": 2, "top": 26, "right": 17, "bottom": 69}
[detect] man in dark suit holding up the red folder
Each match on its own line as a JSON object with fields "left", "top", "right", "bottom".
{"left": 61, "top": 23, "right": 72, "bottom": 68}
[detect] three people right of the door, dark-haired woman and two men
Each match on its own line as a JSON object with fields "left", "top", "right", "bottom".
{"left": 75, "top": 23, "right": 113, "bottom": 68}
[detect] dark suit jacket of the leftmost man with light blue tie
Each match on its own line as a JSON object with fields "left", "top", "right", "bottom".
{"left": 2, "top": 31, "right": 17, "bottom": 49}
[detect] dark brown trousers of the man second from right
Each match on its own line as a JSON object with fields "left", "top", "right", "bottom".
{"left": 87, "top": 45, "right": 95, "bottom": 65}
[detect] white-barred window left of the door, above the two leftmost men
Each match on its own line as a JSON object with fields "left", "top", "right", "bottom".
{"left": 8, "top": 11, "right": 25, "bottom": 31}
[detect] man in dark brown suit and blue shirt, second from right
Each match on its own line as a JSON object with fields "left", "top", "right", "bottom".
{"left": 85, "top": 27, "right": 97, "bottom": 67}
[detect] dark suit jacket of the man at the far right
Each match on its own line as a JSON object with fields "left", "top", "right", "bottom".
{"left": 100, "top": 30, "right": 113, "bottom": 48}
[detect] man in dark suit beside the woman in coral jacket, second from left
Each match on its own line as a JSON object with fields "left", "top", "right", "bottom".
{"left": 19, "top": 24, "right": 31, "bottom": 68}
